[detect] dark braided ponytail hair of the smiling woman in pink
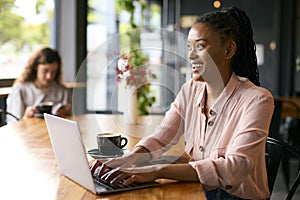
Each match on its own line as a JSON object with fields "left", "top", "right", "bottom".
{"left": 195, "top": 7, "right": 260, "bottom": 86}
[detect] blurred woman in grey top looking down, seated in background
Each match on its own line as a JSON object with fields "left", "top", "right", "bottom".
{"left": 7, "top": 47, "right": 71, "bottom": 121}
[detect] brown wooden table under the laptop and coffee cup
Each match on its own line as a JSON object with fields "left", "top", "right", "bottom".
{"left": 0, "top": 114, "right": 205, "bottom": 200}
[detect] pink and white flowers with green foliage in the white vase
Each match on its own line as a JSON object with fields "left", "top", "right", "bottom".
{"left": 116, "top": 54, "right": 156, "bottom": 115}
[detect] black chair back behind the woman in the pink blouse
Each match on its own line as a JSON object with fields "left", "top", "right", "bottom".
{"left": 266, "top": 137, "right": 300, "bottom": 200}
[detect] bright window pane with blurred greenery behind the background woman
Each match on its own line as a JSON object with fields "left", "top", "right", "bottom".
{"left": 0, "top": 0, "right": 54, "bottom": 79}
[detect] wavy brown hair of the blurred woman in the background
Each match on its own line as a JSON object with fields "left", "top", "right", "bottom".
{"left": 15, "top": 47, "right": 62, "bottom": 84}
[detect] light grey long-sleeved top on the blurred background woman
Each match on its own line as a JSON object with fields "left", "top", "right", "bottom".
{"left": 6, "top": 82, "right": 71, "bottom": 122}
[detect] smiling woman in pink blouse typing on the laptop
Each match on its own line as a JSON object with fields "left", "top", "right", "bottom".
{"left": 91, "top": 7, "right": 274, "bottom": 199}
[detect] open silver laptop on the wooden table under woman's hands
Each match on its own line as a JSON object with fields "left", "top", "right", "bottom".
{"left": 44, "top": 113, "right": 159, "bottom": 194}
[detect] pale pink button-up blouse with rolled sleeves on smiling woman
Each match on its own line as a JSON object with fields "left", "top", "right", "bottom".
{"left": 137, "top": 74, "right": 274, "bottom": 199}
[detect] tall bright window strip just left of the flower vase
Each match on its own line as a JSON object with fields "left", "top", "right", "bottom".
{"left": 85, "top": 0, "right": 117, "bottom": 111}
